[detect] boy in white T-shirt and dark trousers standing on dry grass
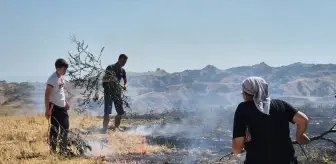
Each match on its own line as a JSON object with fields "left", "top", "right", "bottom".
{"left": 45, "top": 58, "right": 69, "bottom": 153}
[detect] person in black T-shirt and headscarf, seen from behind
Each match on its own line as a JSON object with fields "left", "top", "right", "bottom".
{"left": 232, "top": 76, "right": 309, "bottom": 164}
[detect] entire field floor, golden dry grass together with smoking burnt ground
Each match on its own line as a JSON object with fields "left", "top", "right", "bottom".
{"left": 0, "top": 105, "right": 336, "bottom": 164}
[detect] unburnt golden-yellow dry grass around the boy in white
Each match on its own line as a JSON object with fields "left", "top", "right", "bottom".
{"left": 0, "top": 116, "right": 168, "bottom": 164}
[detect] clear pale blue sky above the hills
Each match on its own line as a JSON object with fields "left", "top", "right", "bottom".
{"left": 0, "top": 0, "right": 336, "bottom": 81}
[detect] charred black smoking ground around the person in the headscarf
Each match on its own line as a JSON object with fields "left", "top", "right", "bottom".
{"left": 80, "top": 104, "right": 336, "bottom": 164}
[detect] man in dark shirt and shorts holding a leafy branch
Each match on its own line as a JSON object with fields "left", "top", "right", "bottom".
{"left": 103, "top": 54, "right": 128, "bottom": 132}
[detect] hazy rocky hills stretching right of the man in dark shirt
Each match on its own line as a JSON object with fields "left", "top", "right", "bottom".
{"left": 125, "top": 62, "right": 336, "bottom": 111}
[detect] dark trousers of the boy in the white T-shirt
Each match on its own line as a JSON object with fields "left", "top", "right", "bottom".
{"left": 49, "top": 104, "right": 69, "bottom": 151}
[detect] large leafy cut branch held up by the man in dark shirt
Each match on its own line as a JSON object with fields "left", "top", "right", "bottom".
{"left": 68, "top": 36, "right": 130, "bottom": 114}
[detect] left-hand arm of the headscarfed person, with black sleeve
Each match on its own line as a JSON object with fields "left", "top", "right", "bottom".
{"left": 232, "top": 105, "right": 246, "bottom": 154}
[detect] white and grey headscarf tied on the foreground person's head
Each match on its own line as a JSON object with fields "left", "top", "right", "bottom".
{"left": 242, "top": 76, "right": 271, "bottom": 114}
